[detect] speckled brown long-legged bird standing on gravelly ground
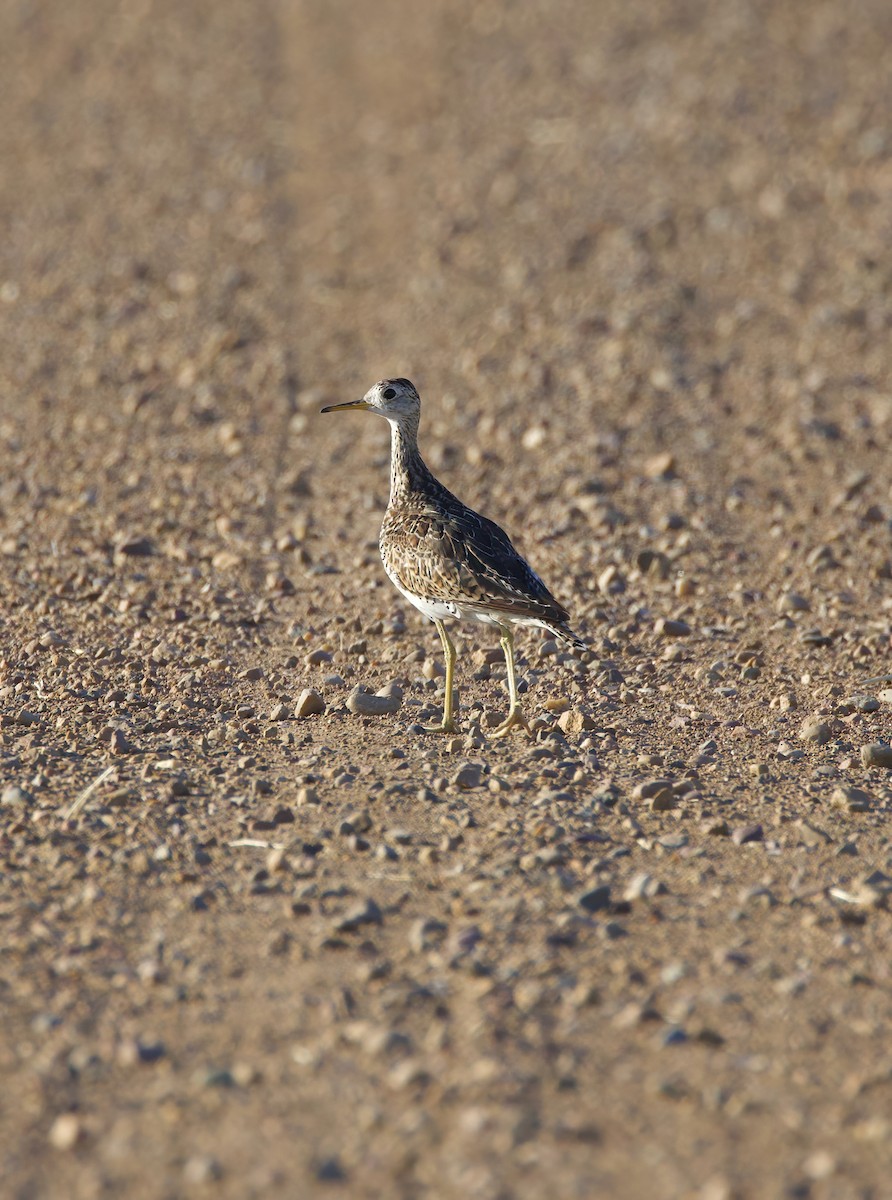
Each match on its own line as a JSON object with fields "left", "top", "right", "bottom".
{"left": 322, "top": 378, "right": 586, "bottom": 738}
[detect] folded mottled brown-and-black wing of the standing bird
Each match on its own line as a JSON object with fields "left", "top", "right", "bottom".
{"left": 381, "top": 488, "right": 568, "bottom": 624}
